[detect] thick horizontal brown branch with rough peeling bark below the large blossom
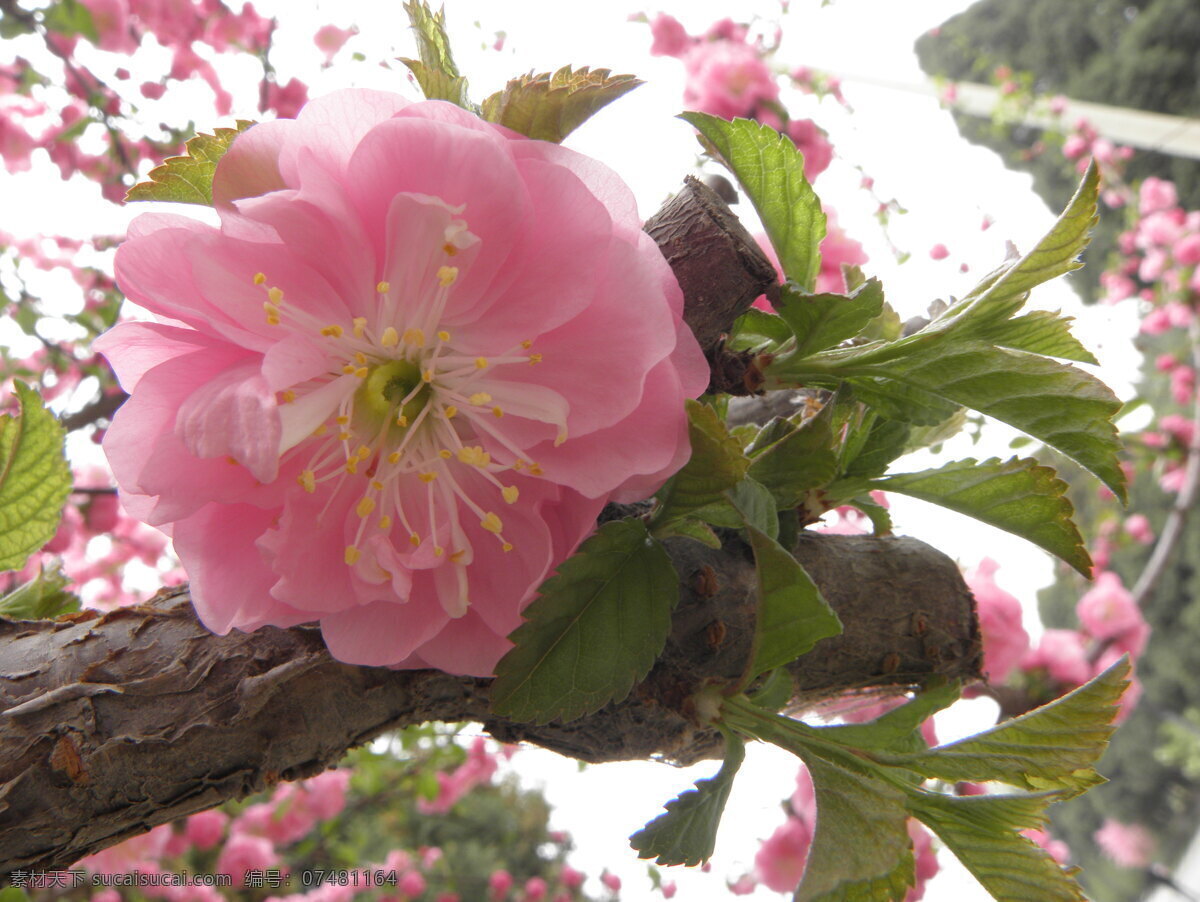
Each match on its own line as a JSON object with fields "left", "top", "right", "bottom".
{"left": 0, "top": 536, "right": 979, "bottom": 874}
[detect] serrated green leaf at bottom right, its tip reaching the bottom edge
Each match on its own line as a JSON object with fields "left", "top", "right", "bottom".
{"left": 910, "top": 793, "right": 1087, "bottom": 902}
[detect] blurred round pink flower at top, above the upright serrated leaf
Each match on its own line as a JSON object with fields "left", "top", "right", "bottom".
{"left": 683, "top": 41, "right": 779, "bottom": 119}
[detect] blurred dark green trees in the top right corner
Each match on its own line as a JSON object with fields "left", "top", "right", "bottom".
{"left": 917, "top": 0, "right": 1200, "bottom": 300}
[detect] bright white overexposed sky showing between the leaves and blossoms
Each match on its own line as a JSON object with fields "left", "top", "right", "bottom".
{"left": 0, "top": 0, "right": 1136, "bottom": 902}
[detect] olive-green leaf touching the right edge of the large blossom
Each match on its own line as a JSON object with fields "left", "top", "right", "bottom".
{"left": 652, "top": 401, "right": 750, "bottom": 536}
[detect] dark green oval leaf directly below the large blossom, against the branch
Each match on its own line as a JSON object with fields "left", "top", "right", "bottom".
{"left": 492, "top": 519, "right": 679, "bottom": 723}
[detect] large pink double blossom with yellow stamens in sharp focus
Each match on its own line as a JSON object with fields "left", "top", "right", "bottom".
{"left": 98, "top": 90, "right": 708, "bottom": 675}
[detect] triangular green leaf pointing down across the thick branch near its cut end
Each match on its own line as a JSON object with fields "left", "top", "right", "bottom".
{"left": 746, "top": 525, "right": 841, "bottom": 680}
